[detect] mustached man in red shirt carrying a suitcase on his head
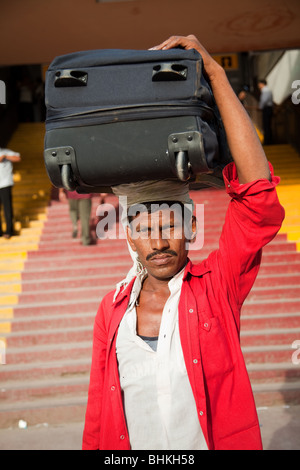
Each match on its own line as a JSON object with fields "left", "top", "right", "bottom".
{"left": 83, "top": 36, "right": 284, "bottom": 450}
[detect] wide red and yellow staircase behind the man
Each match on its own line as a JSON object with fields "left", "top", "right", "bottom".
{"left": 0, "top": 126, "right": 300, "bottom": 428}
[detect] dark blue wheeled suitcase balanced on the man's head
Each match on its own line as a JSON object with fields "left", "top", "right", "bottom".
{"left": 44, "top": 49, "right": 230, "bottom": 192}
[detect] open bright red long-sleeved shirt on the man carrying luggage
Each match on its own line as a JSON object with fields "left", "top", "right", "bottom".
{"left": 83, "top": 163, "right": 284, "bottom": 450}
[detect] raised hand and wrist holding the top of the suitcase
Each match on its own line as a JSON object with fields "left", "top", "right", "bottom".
{"left": 150, "top": 34, "right": 223, "bottom": 81}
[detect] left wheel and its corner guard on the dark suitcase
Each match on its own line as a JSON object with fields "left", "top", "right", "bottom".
{"left": 44, "top": 146, "right": 78, "bottom": 191}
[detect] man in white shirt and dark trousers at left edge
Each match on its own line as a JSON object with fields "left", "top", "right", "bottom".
{"left": 0, "top": 148, "right": 21, "bottom": 239}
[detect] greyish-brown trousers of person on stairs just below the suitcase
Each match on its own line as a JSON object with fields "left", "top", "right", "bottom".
{"left": 69, "top": 199, "right": 92, "bottom": 245}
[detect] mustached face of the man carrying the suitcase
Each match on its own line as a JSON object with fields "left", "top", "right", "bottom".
{"left": 127, "top": 208, "right": 196, "bottom": 280}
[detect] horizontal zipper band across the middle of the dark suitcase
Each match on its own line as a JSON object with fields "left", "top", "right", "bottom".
{"left": 46, "top": 104, "right": 216, "bottom": 131}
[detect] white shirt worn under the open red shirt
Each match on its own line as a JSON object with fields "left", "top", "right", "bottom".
{"left": 116, "top": 270, "right": 207, "bottom": 450}
